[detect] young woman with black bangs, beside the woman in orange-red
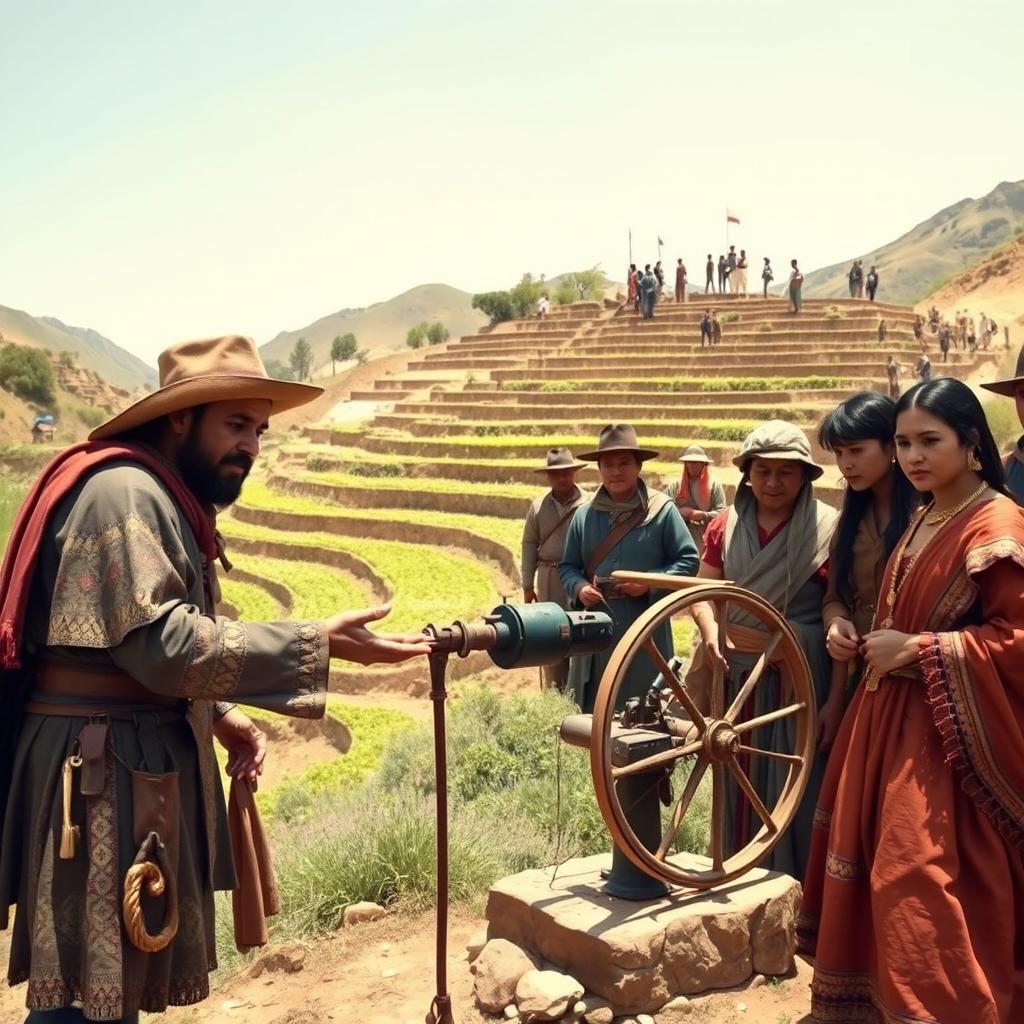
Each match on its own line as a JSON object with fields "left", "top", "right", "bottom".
{"left": 818, "top": 391, "right": 918, "bottom": 752}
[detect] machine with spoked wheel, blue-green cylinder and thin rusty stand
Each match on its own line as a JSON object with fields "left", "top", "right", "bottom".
{"left": 426, "top": 571, "right": 815, "bottom": 1024}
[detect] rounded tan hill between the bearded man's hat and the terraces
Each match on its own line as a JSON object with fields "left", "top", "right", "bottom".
{"left": 260, "top": 285, "right": 487, "bottom": 373}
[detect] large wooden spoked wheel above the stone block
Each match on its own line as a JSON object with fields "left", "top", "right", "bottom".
{"left": 591, "top": 572, "right": 816, "bottom": 889}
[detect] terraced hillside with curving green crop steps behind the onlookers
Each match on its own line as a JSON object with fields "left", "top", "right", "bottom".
{"left": 224, "top": 296, "right": 999, "bottom": 692}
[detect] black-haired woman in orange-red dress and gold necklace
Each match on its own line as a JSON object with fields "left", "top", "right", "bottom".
{"left": 799, "top": 378, "right": 1024, "bottom": 1024}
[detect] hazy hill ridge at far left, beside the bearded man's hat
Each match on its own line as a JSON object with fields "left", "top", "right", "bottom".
{"left": 0, "top": 306, "right": 157, "bottom": 391}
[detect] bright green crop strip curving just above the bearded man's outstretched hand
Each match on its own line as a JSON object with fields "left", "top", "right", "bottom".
{"left": 222, "top": 516, "right": 500, "bottom": 633}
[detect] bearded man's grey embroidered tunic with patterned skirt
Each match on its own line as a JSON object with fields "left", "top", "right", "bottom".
{"left": 0, "top": 463, "right": 329, "bottom": 1020}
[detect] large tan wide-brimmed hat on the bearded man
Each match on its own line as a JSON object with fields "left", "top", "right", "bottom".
{"left": 89, "top": 335, "right": 324, "bottom": 441}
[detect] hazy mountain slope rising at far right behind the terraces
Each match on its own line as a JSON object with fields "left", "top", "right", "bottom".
{"left": 804, "top": 181, "right": 1024, "bottom": 304}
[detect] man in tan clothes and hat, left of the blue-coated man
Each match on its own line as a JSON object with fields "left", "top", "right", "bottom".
{"left": 522, "top": 447, "right": 587, "bottom": 689}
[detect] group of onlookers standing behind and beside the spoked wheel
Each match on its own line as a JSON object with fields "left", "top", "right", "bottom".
{"left": 522, "top": 349, "right": 1024, "bottom": 1022}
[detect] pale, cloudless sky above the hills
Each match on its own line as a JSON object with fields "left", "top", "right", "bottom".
{"left": 0, "top": 0, "right": 1024, "bottom": 361}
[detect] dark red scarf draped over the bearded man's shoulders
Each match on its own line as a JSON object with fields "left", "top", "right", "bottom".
{"left": 0, "top": 441, "right": 217, "bottom": 669}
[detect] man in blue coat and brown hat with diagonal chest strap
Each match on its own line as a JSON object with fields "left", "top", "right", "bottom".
{"left": 559, "top": 423, "right": 697, "bottom": 712}
